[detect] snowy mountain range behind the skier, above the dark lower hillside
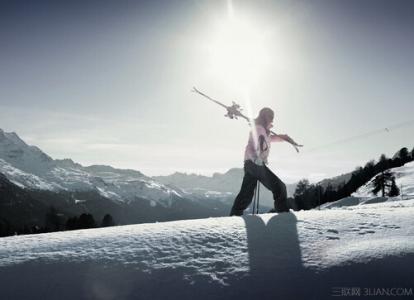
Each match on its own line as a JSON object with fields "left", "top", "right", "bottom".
{"left": 0, "top": 129, "right": 295, "bottom": 210}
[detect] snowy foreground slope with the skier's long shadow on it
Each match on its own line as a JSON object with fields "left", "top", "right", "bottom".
{"left": 0, "top": 200, "right": 414, "bottom": 300}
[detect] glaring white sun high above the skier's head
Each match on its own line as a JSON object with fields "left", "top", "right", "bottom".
{"left": 208, "top": 14, "right": 269, "bottom": 88}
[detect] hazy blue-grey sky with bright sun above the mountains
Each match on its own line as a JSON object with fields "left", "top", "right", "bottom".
{"left": 0, "top": 0, "right": 414, "bottom": 182}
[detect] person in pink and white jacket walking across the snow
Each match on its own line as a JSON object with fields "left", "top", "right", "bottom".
{"left": 230, "top": 107, "right": 301, "bottom": 216}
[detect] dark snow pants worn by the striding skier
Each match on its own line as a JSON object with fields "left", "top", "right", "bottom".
{"left": 230, "top": 160, "right": 289, "bottom": 216}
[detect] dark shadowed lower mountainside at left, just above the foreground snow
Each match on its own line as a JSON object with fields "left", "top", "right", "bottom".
{"left": 0, "top": 173, "right": 230, "bottom": 236}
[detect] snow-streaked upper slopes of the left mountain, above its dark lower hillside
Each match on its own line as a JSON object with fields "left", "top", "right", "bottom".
{"left": 0, "top": 129, "right": 182, "bottom": 205}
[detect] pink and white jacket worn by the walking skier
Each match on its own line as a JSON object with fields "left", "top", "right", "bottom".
{"left": 244, "top": 125, "right": 283, "bottom": 165}
